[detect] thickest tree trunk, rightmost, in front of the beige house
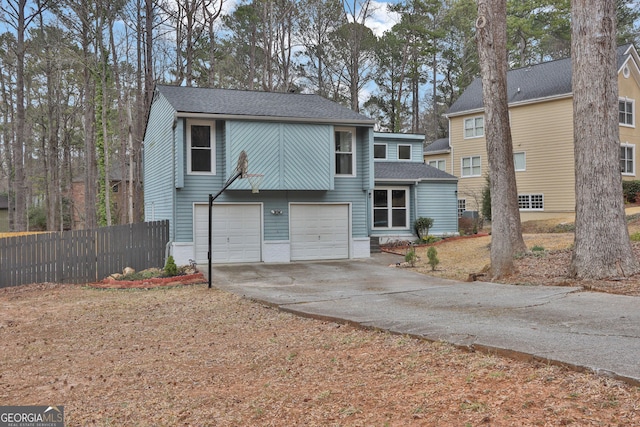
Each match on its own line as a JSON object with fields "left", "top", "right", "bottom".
{"left": 570, "top": 0, "right": 639, "bottom": 279}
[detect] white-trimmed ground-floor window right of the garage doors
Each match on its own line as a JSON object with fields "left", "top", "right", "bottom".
{"left": 373, "top": 187, "right": 409, "bottom": 229}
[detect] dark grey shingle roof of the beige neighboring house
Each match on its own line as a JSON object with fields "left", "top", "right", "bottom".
{"left": 447, "top": 44, "right": 631, "bottom": 115}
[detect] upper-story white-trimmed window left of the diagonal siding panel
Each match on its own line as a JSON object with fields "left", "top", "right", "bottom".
{"left": 187, "top": 120, "right": 216, "bottom": 175}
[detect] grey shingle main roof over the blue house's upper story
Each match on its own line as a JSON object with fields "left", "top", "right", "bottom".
{"left": 156, "top": 85, "right": 375, "bottom": 125}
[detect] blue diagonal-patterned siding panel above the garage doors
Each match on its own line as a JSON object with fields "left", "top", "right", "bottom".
{"left": 226, "top": 121, "right": 333, "bottom": 190}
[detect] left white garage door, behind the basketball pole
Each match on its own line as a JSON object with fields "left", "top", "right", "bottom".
{"left": 194, "top": 204, "right": 262, "bottom": 263}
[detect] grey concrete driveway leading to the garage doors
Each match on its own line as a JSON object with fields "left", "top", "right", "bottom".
{"left": 206, "top": 254, "right": 640, "bottom": 385}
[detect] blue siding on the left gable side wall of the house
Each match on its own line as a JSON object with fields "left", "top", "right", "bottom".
{"left": 144, "top": 95, "right": 175, "bottom": 237}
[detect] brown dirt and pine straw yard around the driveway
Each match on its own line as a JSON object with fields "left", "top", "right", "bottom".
{"left": 0, "top": 216, "right": 640, "bottom": 426}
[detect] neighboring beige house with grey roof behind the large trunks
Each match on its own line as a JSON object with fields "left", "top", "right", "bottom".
{"left": 424, "top": 44, "right": 640, "bottom": 221}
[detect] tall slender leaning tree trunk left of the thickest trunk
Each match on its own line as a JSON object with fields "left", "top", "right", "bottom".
{"left": 476, "top": 0, "right": 527, "bottom": 279}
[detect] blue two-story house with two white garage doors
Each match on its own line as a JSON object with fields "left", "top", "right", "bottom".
{"left": 144, "top": 85, "right": 457, "bottom": 264}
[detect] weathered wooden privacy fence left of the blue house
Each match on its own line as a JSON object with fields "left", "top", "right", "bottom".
{"left": 0, "top": 221, "right": 169, "bottom": 288}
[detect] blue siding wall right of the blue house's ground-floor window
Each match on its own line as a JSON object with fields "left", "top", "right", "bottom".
{"left": 417, "top": 181, "right": 458, "bottom": 234}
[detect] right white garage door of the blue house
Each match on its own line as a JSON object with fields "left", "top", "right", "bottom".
{"left": 289, "top": 204, "right": 349, "bottom": 261}
